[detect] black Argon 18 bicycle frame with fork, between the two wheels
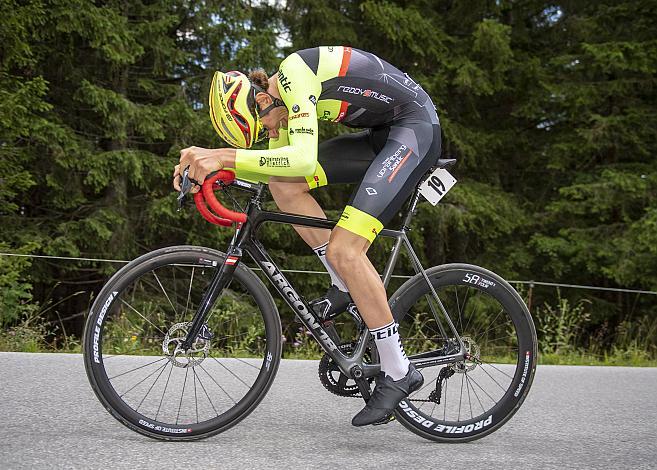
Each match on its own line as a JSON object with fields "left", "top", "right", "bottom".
{"left": 182, "top": 180, "right": 465, "bottom": 392}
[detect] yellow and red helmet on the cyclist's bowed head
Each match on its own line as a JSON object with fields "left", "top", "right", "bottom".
{"left": 210, "top": 71, "right": 266, "bottom": 149}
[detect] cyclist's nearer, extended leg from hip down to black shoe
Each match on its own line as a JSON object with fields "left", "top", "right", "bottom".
{"left": 327, "top": 119, "right": 440, "bottom": 426}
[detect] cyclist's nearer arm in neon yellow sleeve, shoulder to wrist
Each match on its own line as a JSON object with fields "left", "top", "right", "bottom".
{"left": 235, "top": 54, "right": 322, "bottom": 176}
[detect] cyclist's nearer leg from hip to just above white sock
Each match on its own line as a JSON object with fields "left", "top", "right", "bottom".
{"left": 327, "top": 121, "right": 440, "bottom": 329}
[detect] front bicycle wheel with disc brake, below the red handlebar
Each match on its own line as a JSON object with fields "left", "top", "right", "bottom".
{"left": 83, "top": 246, "right": 282, "bottom": 440}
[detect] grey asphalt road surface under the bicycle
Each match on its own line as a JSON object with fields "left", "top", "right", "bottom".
{"left": 0, "top": 353, "right": 657, "bottom": 470}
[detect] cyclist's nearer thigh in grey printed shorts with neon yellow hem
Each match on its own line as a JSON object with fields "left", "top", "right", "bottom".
{"left": 338, "top": 120, "right": 440, "bottom": 241}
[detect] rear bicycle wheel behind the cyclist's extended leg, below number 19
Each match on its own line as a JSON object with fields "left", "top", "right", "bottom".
{"left": 390, "top": 264, "right": 538, "bottom": 442}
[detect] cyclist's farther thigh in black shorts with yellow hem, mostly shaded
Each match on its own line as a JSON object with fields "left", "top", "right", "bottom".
{"left": 306, "top": 129, "right": 376, "bottom": 189}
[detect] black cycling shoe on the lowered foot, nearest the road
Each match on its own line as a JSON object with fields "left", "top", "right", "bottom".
{"left": 351, "top": 364, "right": 424, "bottom": 426}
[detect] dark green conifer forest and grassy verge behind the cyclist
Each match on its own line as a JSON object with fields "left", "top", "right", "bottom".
{"left": 0, "top": 0, "right": 657, "bottom": 365}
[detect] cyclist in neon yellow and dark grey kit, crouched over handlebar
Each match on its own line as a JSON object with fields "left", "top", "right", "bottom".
{"left": 174, "top": 46, "right": 441, "bottom": 426}
